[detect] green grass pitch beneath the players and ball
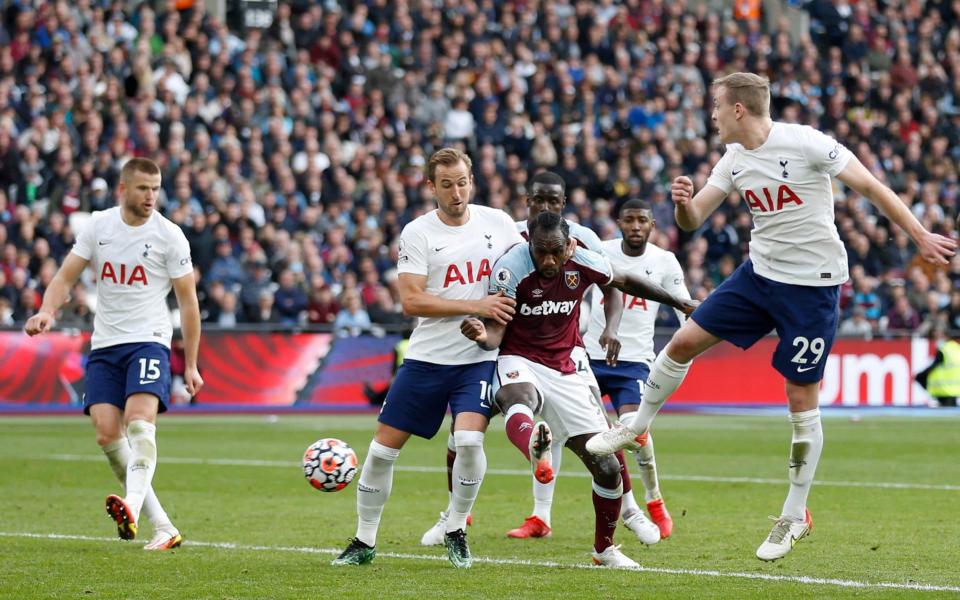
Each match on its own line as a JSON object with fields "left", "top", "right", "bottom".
{"left": 0, "top": 415, "right": 960, "bottom": 599}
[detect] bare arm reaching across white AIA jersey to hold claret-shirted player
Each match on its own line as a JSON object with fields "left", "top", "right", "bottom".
{"left": 397, "top": 273, "right": 517, "bottom": 325}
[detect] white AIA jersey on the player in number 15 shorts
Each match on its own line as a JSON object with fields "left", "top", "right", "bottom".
{"left": 73, "top": 206, "right": 193, "bottom": 350}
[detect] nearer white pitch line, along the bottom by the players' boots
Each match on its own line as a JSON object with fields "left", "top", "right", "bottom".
{"left": 0, "top": 531, "right": 960, "bottom": 592}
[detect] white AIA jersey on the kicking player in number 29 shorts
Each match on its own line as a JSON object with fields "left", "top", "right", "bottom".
{"left": 707, "top": 123, "right": 853, "bottom": 286}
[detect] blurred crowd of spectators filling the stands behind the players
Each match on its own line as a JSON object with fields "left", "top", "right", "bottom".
{"left": 0, "top": 0, "right": 960, "bottom": 337}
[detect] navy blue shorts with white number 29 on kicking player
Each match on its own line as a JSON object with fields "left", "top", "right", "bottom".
{"left": 691, "top": 260, "right": 840, "bottom": 383}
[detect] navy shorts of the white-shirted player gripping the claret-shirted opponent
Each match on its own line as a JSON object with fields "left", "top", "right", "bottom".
{"left": 378, "top": 358, "right": 497, "bottom": 439}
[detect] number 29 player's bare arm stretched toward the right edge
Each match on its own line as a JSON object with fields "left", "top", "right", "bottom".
{"left": 837, "top": 156, "right": 957, "bottom": 265}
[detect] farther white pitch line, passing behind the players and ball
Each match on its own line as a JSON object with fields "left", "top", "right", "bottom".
{"left": 43, "top": 454, "right": 960, "bottom": 492}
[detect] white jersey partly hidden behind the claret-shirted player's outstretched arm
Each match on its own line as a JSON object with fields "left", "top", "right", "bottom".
{"left": 583, "top": 239, "right": 690, "bottom": 365}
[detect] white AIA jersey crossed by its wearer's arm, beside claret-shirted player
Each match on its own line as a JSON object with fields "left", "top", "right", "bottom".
{"left": 397, "top": 204, "right": 523, "bottom": 365}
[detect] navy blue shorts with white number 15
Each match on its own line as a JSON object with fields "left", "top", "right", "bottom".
{"left": 83, "top": 342, "right": 170, "bottom": 415}
